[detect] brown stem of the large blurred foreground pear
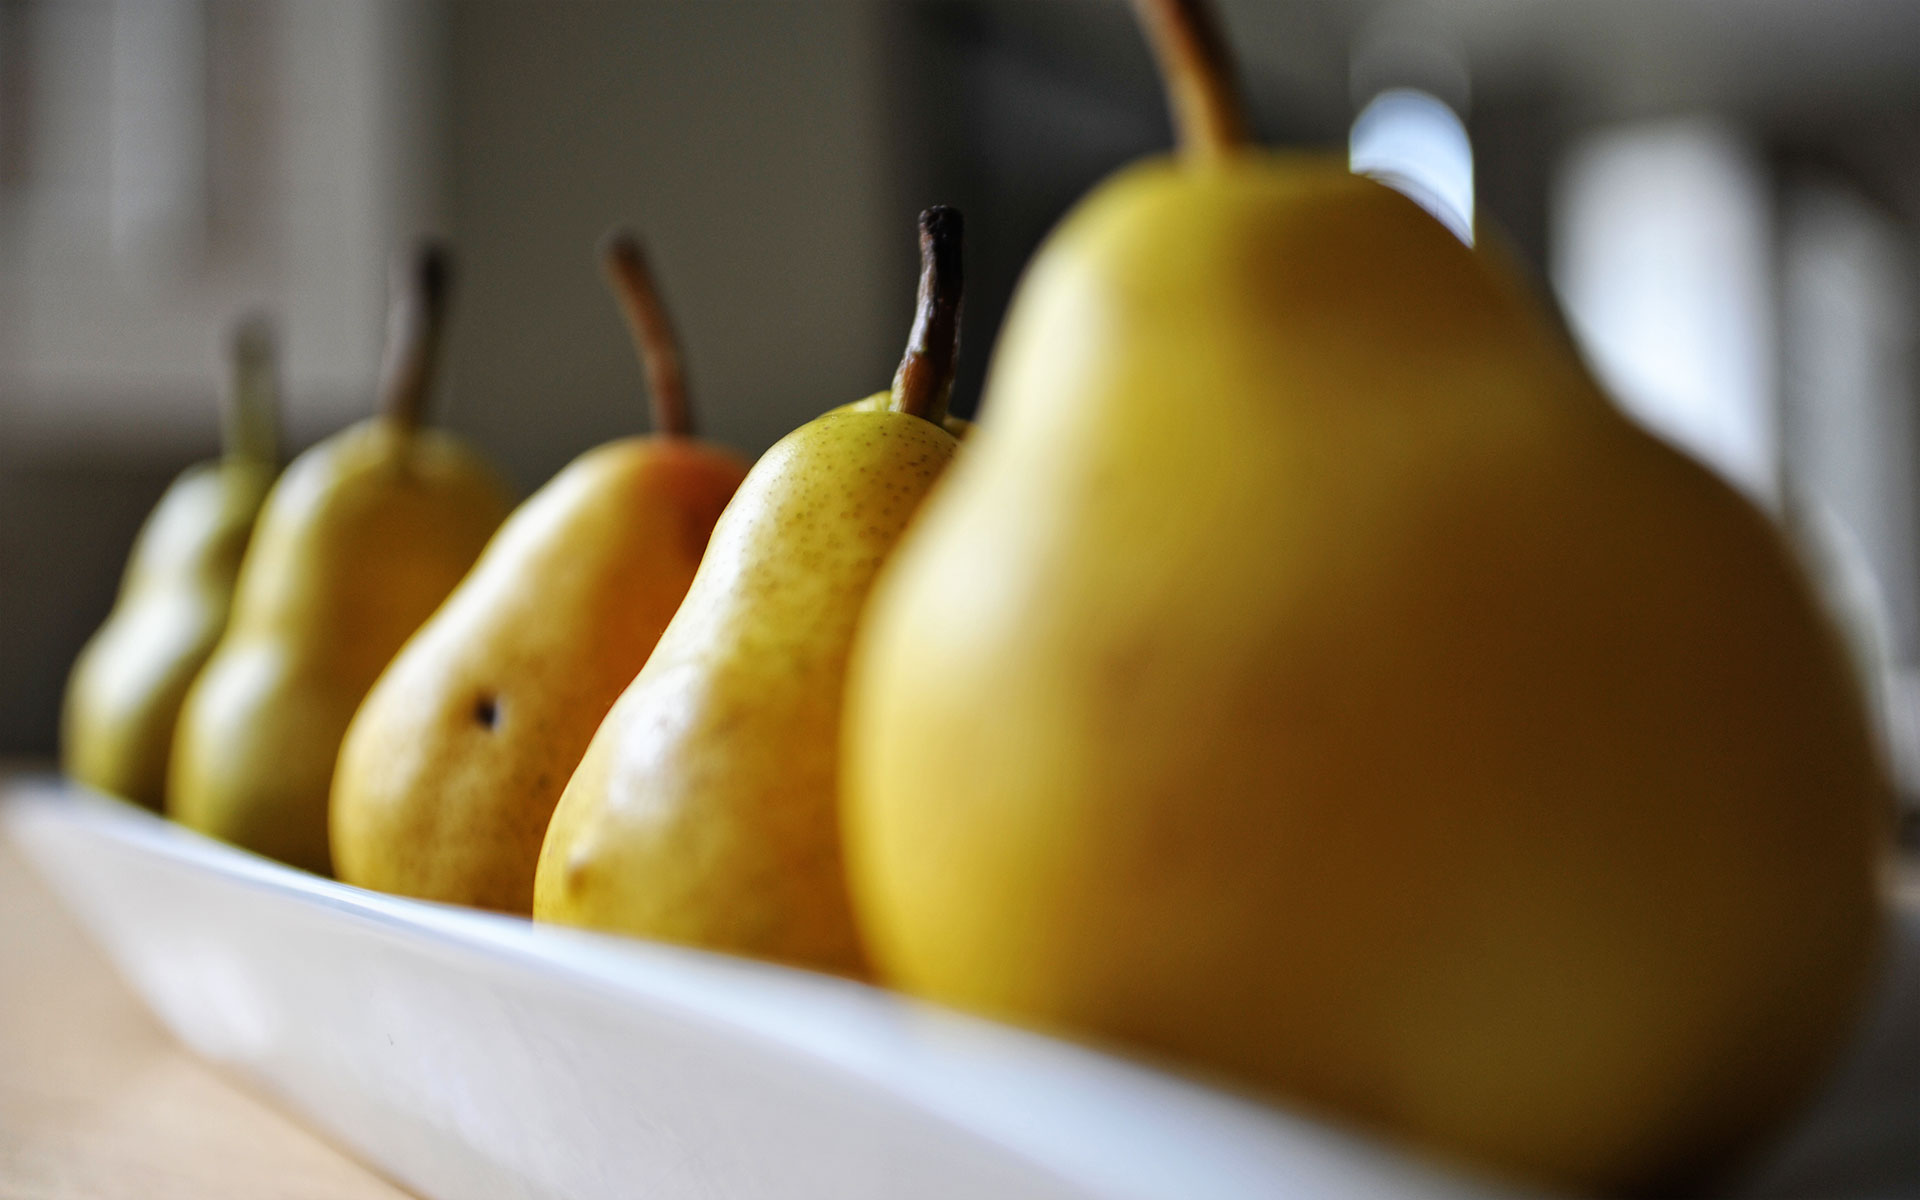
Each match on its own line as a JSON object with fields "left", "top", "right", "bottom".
{"left": 1133, "top": 0, "right": 1248, "bottom": 161}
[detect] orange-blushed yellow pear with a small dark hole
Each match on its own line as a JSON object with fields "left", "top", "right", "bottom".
{"left": 330, "top": 236, "right": 747, "bottom": 914}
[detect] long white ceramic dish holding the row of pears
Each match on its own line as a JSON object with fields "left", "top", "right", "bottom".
{"left": 0, "top": 778, "right": 1920, "bottom": 1200}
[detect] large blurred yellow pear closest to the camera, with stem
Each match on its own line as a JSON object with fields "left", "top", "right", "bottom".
{"left": 843, "top": 0, "right": 1887, "bottom": 1194}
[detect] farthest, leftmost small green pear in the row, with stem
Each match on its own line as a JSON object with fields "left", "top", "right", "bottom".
{"left": 60, "top": 319, "right": 280, "bottom": 810}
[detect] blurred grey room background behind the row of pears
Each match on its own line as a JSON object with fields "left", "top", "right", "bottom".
{"left": 0, "top": 0, "right": 1920, "bottom": 814}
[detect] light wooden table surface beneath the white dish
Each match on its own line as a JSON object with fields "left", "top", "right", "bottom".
{"left": 0, "top": 837, "right": 407, "bottom": 1200}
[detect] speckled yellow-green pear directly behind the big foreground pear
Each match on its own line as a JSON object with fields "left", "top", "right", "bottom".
{"left": 534, "top": 207, "right": 960, "bottom": 973}
